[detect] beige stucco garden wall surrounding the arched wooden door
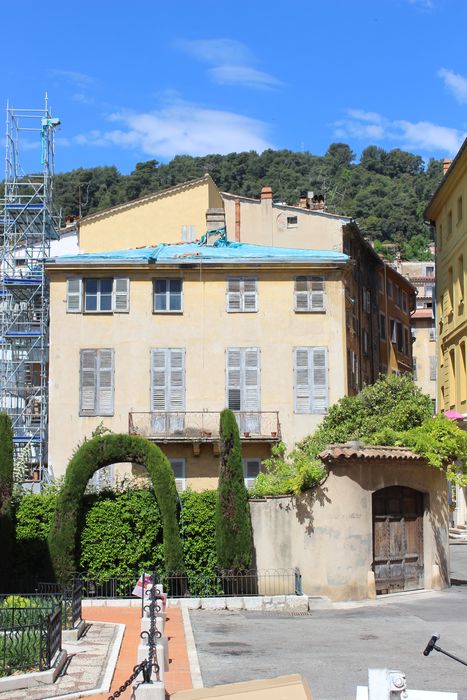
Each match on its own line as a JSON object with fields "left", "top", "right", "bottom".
{"left": 250, "top": 461, "right": 449, "bottom": 600}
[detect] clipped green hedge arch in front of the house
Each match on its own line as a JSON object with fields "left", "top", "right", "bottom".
{"left": 49, "top": 433, "right": 184, "bottom": 583}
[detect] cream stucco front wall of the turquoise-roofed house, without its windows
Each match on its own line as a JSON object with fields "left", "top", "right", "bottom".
{"left": 49, "top": 268, "right": 346, "bottom": 478}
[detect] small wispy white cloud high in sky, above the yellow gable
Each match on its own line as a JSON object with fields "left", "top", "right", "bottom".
{"left": 177, "top": 39, "right": 282, "bottom": 90}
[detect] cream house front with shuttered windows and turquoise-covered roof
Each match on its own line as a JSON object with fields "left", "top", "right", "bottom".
{"left": 47, "top": 242, "right": 348, "bottom": 489}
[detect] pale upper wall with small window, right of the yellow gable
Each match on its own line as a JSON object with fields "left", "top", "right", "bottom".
{"left": 222, "top": 194, "right": 349, "bottom": 252}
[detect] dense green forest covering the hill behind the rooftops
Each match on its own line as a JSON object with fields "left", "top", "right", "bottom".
{"left": 55, "top": 143, "right": 442, "bottom": 260}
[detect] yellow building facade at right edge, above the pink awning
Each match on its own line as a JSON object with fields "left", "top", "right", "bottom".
{"left": 425, "top": 139, "right": 467, "bottom": 417}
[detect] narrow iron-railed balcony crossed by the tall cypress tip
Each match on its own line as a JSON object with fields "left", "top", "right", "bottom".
{"left": 128, "top": 411, "right": 281, "bottom": 442}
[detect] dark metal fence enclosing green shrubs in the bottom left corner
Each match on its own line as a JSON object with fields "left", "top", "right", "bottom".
{"left": 0, "top": 595, "right": 62, "bottom": 676}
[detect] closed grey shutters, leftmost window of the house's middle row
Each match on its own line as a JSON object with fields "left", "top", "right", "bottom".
{"left": 79, "top": 348, "right": 114, "bottom": 416}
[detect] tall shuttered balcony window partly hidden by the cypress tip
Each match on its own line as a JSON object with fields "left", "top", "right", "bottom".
{"left": 226, "top": 348, "right": 260, "bottom": 433}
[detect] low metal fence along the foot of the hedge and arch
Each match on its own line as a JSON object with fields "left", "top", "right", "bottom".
{"left": 76, "top": 569, "right": 302, "bottom": 598}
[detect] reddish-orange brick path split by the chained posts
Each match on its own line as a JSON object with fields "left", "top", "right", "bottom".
{"left": 83, "top": 604, "right": 193, "bottom": 700}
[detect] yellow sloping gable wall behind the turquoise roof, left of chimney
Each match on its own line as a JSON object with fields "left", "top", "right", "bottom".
{"left": 79, "top": 177, "right": 222, "bottom": 253}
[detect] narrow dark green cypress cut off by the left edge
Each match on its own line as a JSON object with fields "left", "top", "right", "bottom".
{"left": 0, "top": 413, "right": 14, "bottom": 590}
